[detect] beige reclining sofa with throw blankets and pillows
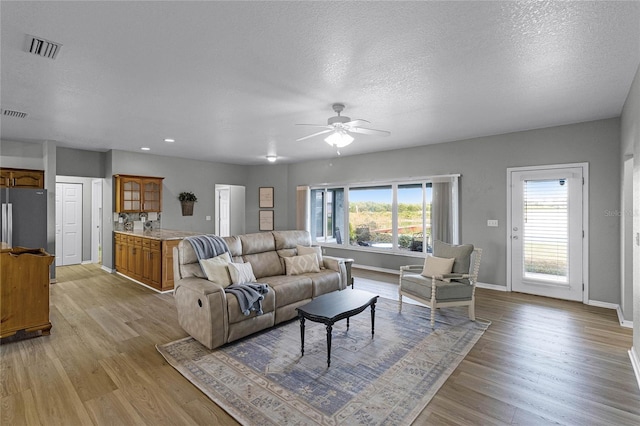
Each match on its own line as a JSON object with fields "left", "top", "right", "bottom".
{"left": 173, "top": 231, "right": 352, "bottom": 349}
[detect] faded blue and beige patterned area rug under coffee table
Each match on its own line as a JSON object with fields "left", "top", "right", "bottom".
{"left": 157, "top": 298, "right": 490, "bottom": 425}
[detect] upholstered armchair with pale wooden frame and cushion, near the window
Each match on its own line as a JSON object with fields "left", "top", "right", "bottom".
{"left": 398, "top": 241, "right": 482, "bottom": 328}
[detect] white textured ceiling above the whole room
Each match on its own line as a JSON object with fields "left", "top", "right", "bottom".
{"left": 0, "top": 1, "right": 640, "bottom": 164}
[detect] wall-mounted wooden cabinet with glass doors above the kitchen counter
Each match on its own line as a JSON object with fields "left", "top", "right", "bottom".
{"left": 113, "top": 175, "right": 164, "bottom": 213}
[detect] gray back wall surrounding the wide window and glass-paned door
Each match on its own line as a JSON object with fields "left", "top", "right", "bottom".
{"left": 288, "top": 118, "right": 620, "bottom": 303}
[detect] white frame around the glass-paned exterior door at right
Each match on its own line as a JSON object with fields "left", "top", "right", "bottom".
{"left": 506, "top": 163, "right": 589, "bottom": 304}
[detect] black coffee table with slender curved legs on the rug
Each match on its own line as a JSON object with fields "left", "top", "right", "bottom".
{"left": 296, "top": 289, "right": 378, "bottom": 368}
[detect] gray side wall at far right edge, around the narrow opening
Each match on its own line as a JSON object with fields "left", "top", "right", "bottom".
{"left": 620, "top": 63, "right": 640, "bottom": 358}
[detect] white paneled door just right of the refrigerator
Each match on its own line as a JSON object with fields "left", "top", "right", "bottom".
{"left": 56, "top": 183, "right": 82, "bottom": 266}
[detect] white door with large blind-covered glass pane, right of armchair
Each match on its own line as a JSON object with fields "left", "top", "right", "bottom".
{"left": 507, "top": 165, "right": 586, "bottom": 301}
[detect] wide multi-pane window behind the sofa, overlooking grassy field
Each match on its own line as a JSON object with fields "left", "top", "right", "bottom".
{"left": 309, "top": 176, "right": 459, "bottom": 253}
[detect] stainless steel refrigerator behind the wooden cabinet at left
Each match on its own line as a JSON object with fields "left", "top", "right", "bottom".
{"left": 0, "top": 188, "right": 47, "bottom": 250}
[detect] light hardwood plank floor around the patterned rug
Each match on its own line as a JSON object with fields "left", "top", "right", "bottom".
{"left": 0, "top": 265, "right": 640, "bottom": 426}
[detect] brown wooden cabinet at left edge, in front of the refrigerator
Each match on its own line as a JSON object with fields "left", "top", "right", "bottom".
{"left": 0, "top": 247, "right": 54, "bottom": 338}
